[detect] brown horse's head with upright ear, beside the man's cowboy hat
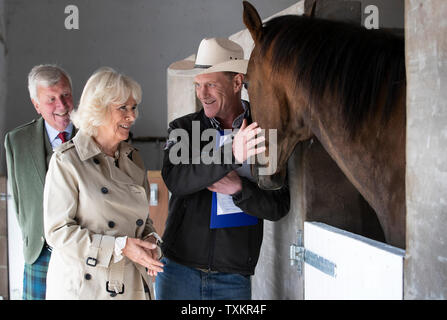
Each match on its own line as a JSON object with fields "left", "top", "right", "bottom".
{"left": 243, "top": 1, "right": 312, "bottom": 190}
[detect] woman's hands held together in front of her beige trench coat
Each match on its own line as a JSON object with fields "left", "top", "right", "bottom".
{"left": 122, "top": 237, "right": 163, "bottom": 277}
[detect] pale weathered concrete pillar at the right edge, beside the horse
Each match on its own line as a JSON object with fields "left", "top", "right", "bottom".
{"left": 404, "top": 0, "right": 447, "bottom": 299}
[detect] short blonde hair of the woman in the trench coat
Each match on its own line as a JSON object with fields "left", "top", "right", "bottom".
{"left": 70, "top": 67, "right": 142, "bottom": 136}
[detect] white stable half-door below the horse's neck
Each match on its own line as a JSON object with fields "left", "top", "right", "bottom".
{"left": 304, "top": 222, "right": 405, "bottom": 300}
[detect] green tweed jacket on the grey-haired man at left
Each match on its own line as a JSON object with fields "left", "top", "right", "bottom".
{"left": 5, "top": 117, "right": 75, "bottom": 264}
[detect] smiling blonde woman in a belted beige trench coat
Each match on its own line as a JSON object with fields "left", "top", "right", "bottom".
{"left": 44, "top": 68, "right": 163, "bottom": 299}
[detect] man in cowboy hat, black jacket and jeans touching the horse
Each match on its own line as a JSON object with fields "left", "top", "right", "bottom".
{"left": 155, "top": 38, "right": 290, "bottom": 300}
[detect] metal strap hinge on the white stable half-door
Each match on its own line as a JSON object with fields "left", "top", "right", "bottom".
{"left": 290, "top": 230, "right": 337, "bottom": 278}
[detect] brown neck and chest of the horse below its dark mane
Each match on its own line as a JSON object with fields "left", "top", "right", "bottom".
{"left": 305, "top": 92, "right": 405, "bottom": 221}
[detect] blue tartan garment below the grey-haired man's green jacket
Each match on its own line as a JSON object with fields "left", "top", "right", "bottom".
{"left": 22, "top": 246, "right": 51, "bottom": 300}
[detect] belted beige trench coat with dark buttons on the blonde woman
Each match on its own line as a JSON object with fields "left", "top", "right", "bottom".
{"left": 44, "top": 132, "right": 155, "bottom": 299}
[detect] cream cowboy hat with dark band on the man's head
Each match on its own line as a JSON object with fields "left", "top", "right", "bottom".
{"left": 172, "top": 38, "right": 248, "bottom": 74}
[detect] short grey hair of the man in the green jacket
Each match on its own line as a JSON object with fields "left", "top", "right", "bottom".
{"left": 28, "top": 64, "right": 72, "bottom": 102}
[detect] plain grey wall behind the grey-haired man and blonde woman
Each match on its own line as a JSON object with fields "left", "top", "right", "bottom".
{"left": 0, "top": 0, "right": 295, "bottom": 173}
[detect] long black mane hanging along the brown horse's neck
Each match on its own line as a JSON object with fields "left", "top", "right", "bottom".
{"left": 260, "top": 15, "right": 405, "bottom": 136}
